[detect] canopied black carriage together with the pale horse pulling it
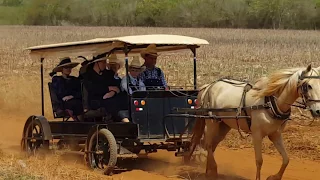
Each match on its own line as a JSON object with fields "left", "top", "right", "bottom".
{"left": 21, "top": 35, "right": 320, "bottom": 180}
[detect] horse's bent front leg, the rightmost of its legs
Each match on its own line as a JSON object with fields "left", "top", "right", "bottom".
{"left": 267, "top": 131, "right": 289, "bottom": 180}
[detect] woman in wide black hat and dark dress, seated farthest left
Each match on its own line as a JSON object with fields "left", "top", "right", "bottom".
{"left": 50, "top": 57, "right": 83, "bottom": 119}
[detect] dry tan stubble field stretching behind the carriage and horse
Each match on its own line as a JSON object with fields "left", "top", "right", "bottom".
{"left": 0, "top": 26, "right": 320, "bottom": 179}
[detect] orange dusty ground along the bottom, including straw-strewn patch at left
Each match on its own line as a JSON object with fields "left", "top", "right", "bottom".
{"left": 0, "top": 113, "right": 320, "bottom": 180}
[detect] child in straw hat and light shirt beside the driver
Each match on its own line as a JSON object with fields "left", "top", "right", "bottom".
{"left": 121, "top": 56, "right": 146, "bottom": 94}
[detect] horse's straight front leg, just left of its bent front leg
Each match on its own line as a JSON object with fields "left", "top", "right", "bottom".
{"left": 252, "top": 131, "right": 263, "bottom": 180}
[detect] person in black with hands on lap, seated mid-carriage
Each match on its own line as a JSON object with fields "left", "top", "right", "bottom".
{"left": 84, "top": 52, "right": 128, "bottom": 122}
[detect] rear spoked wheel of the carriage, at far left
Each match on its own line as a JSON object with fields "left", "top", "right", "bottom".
{"left": 21, "top": 118, "right": 49, "bottom": 155}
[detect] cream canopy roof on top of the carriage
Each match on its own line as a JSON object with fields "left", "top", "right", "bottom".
{"left": 27, "top": 34, "right": 209, "bottom": 58}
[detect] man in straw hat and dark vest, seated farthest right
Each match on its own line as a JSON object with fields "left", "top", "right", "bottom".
{"left": 140, "top": 44, "right": 169, "bottom": 90}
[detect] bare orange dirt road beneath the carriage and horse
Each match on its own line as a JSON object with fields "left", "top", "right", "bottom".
{"left": 0, "top": 114, "right": 320, "bottom": 180}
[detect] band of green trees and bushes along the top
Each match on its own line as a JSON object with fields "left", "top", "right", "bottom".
{"left": 0, "top": 0, "right": 320, "bottom": 29}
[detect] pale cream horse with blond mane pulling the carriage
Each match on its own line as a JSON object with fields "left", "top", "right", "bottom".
{"left": 186, "top": 65, "right": 320, "bottom": 180}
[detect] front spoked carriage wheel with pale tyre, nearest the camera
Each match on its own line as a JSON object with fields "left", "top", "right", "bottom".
{"left": 85, "top": 129, "right": 117, "bottom": 175}
